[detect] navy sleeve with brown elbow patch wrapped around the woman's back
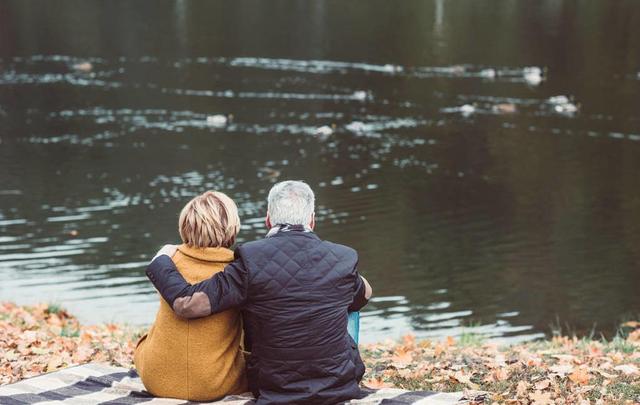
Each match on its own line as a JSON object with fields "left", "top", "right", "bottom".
{"left": 146, "top": 252, "right": 248, "bottom": 318}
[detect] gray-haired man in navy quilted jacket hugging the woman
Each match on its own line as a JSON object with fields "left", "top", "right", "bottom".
{"left": 147, "top": 181, "right": 372, "bottom": 405}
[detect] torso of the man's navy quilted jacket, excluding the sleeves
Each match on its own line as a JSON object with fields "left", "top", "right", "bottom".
{"left": 236, "top": 231, "right": 364, "bottom": 404}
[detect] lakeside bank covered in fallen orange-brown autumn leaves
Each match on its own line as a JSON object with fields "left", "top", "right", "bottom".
{"left": 0, "top": 303, "right": 640, "bottom": 405}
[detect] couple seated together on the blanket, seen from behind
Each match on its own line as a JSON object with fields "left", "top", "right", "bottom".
{"left": 135, "top": 181, "right": 371, "bottom": 404}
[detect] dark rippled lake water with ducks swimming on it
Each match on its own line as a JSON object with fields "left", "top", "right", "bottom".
{"left": 0, "top": 0, "right": 640, "bottom": 342}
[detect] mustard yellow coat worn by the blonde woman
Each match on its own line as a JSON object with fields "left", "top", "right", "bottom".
{"left": 134, "top": 245, "right": 247, "bottom": 401}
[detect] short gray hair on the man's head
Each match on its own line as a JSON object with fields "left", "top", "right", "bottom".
{"left": 267, "top": 180, "right": 316, "bottom": 226}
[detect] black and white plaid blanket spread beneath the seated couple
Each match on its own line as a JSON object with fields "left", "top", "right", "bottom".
{"left": 0, "top": 364, "right": 483, "bottom": 405}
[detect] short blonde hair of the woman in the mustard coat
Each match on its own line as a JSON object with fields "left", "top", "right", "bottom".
{"left": 178, "top": 191, "right": 240, "bottom": 248}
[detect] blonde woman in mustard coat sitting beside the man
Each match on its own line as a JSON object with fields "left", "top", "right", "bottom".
{"left": 134, "top": 191, "right": 247, "bottom": 401}
